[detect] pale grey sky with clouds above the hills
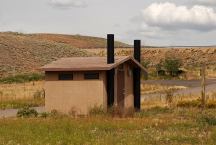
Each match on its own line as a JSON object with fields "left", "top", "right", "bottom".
{"left": 0, "top": 0, "right": 216, "bottom": 46}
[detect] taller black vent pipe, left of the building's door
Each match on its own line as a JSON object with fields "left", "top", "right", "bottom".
{"left": 107, "top": 34, "right": 115, "bottom": 107}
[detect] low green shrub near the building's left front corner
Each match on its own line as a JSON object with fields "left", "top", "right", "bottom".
{"left": 17, "top": 107, "right": 38, "bottom": 117}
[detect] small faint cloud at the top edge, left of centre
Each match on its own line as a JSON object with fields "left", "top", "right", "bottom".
{"left": 50, "top": 0, "right": 87, "bottom": 9}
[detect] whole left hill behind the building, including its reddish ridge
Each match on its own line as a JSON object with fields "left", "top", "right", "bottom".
{"left": 0, "top": 32, "right": 128, "bottom": 77}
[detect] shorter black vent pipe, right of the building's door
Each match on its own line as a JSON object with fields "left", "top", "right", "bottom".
{"left": 133, "top": 40, "right": 141, "bottom": 111}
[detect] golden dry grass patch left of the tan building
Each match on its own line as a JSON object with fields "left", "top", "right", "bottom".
{"left": 0, "top": 81, "right": 45, "bottom": 109}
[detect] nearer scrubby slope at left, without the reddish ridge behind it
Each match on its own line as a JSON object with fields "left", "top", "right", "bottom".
{"left": 0, "top": 33, "right": 85, "bottom": 76}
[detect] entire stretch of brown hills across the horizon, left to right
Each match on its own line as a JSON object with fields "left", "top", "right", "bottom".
{"left": 0, "top": 32, "right": 216, "bottom": 77}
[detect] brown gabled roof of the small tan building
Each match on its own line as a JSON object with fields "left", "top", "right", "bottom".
{"left": 41, "top": 56, "right": 147, "bottom": 72}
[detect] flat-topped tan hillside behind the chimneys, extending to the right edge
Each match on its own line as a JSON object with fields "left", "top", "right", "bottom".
{"left": 92, "top": 47, "right": 216, "bottom": 68}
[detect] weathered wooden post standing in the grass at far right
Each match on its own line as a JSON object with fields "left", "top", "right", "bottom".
{"left": 201, "top": 64, "right": 206, "bottom": 109}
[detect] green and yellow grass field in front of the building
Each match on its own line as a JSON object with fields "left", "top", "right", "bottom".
{"left": 0, "top": 107, "right": 216, "bottom": 145}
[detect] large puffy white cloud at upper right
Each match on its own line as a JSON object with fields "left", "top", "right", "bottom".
{"left": 141, "top": 2, "right": 216, "bottom": 31}
